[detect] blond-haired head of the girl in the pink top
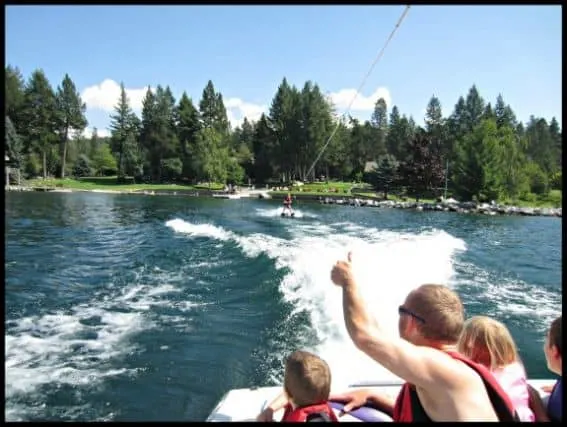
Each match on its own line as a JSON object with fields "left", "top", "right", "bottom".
{"left": 457, "top": 316, "right": 518, "bottom": 370}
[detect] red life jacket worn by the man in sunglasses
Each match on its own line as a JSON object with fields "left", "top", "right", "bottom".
{"left": 393, "top": 351, "right": 520, "bottom": 422}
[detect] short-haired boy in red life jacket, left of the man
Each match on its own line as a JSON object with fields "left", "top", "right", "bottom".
{"left": 256, "top": 350, "right": 338, "bottom": 422}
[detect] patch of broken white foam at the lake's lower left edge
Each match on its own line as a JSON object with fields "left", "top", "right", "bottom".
{"left": 5, "top": 308, "right": 142, "bottom": 397}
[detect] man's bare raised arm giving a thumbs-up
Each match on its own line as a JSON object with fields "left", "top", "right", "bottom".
{"left": 332, "top": 254, "right": 468, "bottom": 389}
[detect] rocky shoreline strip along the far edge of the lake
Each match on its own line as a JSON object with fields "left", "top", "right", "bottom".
{"left": 5, "top": 186, "right": 563, "bottom": 218}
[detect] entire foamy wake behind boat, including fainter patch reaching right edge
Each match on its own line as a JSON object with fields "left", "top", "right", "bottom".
{"left": 171, "top": 216, "right": 561, "bottom": 388}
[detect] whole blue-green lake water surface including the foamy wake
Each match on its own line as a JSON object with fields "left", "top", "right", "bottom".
{"left": 5, "top": 193, "right": 562, "bottom": 421}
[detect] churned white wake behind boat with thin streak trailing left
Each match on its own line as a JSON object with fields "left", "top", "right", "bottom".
{"left": 167, "top": 219, "right": 465, "bottom": 387}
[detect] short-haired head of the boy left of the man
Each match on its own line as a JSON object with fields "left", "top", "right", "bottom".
{"left": 284, "top": 351, "right": 331, "bottom": 407}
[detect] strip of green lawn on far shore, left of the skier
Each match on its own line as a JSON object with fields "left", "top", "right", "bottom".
{"left": 25, "top": 176, "right": 224, "bottom": 191}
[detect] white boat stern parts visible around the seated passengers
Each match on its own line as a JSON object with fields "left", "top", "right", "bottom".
{"left": 207, "top": 380, "right": 554, "bottom": 422}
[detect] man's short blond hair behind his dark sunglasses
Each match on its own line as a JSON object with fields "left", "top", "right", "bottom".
{"left": 406, "top": 284, "right": 465, "bottom": 344}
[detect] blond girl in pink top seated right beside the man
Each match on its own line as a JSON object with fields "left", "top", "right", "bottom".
{"left": 457, "top": 316, "right": 535, "bottom": 422}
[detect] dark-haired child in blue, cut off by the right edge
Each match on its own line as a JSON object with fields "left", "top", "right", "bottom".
{"left": 530, "top": 316, "right": 563, "bottom": 423}
